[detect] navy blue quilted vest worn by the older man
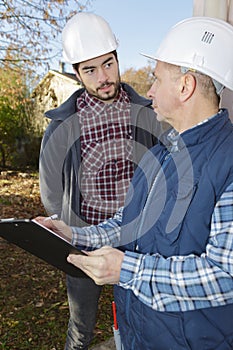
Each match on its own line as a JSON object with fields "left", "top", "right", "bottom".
{"left": 114, "top": 110, "right": 233, "bottom": 350}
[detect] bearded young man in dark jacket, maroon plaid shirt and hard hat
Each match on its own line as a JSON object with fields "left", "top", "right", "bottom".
{"left": 40, "top": 13, "right": 164, "bottom": 350}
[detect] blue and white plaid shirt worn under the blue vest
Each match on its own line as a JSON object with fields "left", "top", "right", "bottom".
{"left": 72, "top": 115, "right": 233, "bottom": 312}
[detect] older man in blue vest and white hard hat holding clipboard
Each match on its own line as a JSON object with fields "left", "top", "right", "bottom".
{"left": 37, "top": 17, "right": 233, "bottom": 350}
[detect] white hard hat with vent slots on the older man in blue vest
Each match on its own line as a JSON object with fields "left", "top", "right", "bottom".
{"left": 143, "top": 17, "right": 233, "bottom": 90}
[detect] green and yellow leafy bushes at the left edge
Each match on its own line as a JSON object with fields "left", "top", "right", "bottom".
{"left": 0, "top": 64, "right": 40, "bottom": 167}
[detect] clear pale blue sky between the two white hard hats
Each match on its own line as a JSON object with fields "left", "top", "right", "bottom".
{"left": 59, "top": 0, "right": 193, "bottom": 73}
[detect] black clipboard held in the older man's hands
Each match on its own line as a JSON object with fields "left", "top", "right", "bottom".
{"left": 0, "top": 218, "right": 87, "bottom": 277}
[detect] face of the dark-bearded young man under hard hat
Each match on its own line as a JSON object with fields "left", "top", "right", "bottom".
{"left": 76, "top": 53, "right": 120, "bottom": 103}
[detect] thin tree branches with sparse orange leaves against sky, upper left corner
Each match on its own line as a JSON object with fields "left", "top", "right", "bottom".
{"left": 0, "top": 0, "right": 91, "bottom": 72}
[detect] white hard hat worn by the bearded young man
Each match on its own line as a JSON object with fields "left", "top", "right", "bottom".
{"left": 62, "top": 12, "right": 118, "bottom": 64}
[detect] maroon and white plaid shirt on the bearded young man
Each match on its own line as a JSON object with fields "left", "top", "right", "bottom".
{"left": 77, "top": 88, "right": 133, "bottom": 224}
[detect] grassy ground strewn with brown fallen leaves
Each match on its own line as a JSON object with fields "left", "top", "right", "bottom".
{"left": 0, "top": 171, "right": 113, "bottom": 350}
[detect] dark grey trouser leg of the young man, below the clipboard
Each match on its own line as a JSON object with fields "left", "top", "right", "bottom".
{"left": 65, "top": 276, "right": 102, "bottom": 350}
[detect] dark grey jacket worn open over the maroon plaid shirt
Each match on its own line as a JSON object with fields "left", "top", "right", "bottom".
{"left": 39, "top": 83, "right": 163, "bottom": 226}
